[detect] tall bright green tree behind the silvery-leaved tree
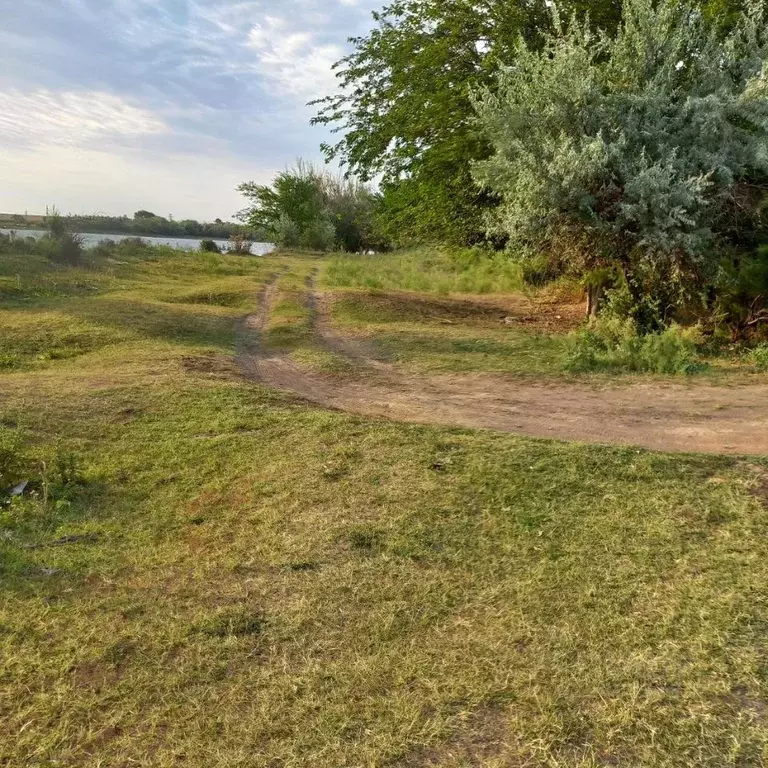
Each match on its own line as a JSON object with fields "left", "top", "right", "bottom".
{"left": 313, "top": 0, "right": 760, "bottom": 243}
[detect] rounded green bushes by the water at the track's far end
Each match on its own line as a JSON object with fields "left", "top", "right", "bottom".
{"left": 238, "top": 161, "right": 380, "bottom": 251}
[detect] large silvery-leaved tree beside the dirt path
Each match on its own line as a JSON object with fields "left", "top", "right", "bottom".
{"left": 474, "top": 0, "right": 768, "bottom": 325}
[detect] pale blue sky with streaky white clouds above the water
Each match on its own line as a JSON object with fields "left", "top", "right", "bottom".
{"left": 0, "top": 0, "right": 383, "bottom": 221}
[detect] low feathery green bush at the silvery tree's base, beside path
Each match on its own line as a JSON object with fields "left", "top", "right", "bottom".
{"left": 566, "top": 315, "right": 701, "bottom": 374}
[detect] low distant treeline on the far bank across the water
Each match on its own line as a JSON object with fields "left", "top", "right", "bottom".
{"left": 0, "top": 211, "right": 266, "bottom": 242}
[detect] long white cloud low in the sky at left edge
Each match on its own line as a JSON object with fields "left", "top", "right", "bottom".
{"left": 0, "top": 90, "right": 168, "bottom": 147}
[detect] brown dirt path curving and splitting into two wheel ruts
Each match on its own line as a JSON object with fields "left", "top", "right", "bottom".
{"left": 238, "top": 275, "right": 768, "bottom": 454}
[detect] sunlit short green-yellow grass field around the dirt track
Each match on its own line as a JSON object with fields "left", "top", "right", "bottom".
{"left": 0, "top": 250, "right": 768, "bottom": 768}
